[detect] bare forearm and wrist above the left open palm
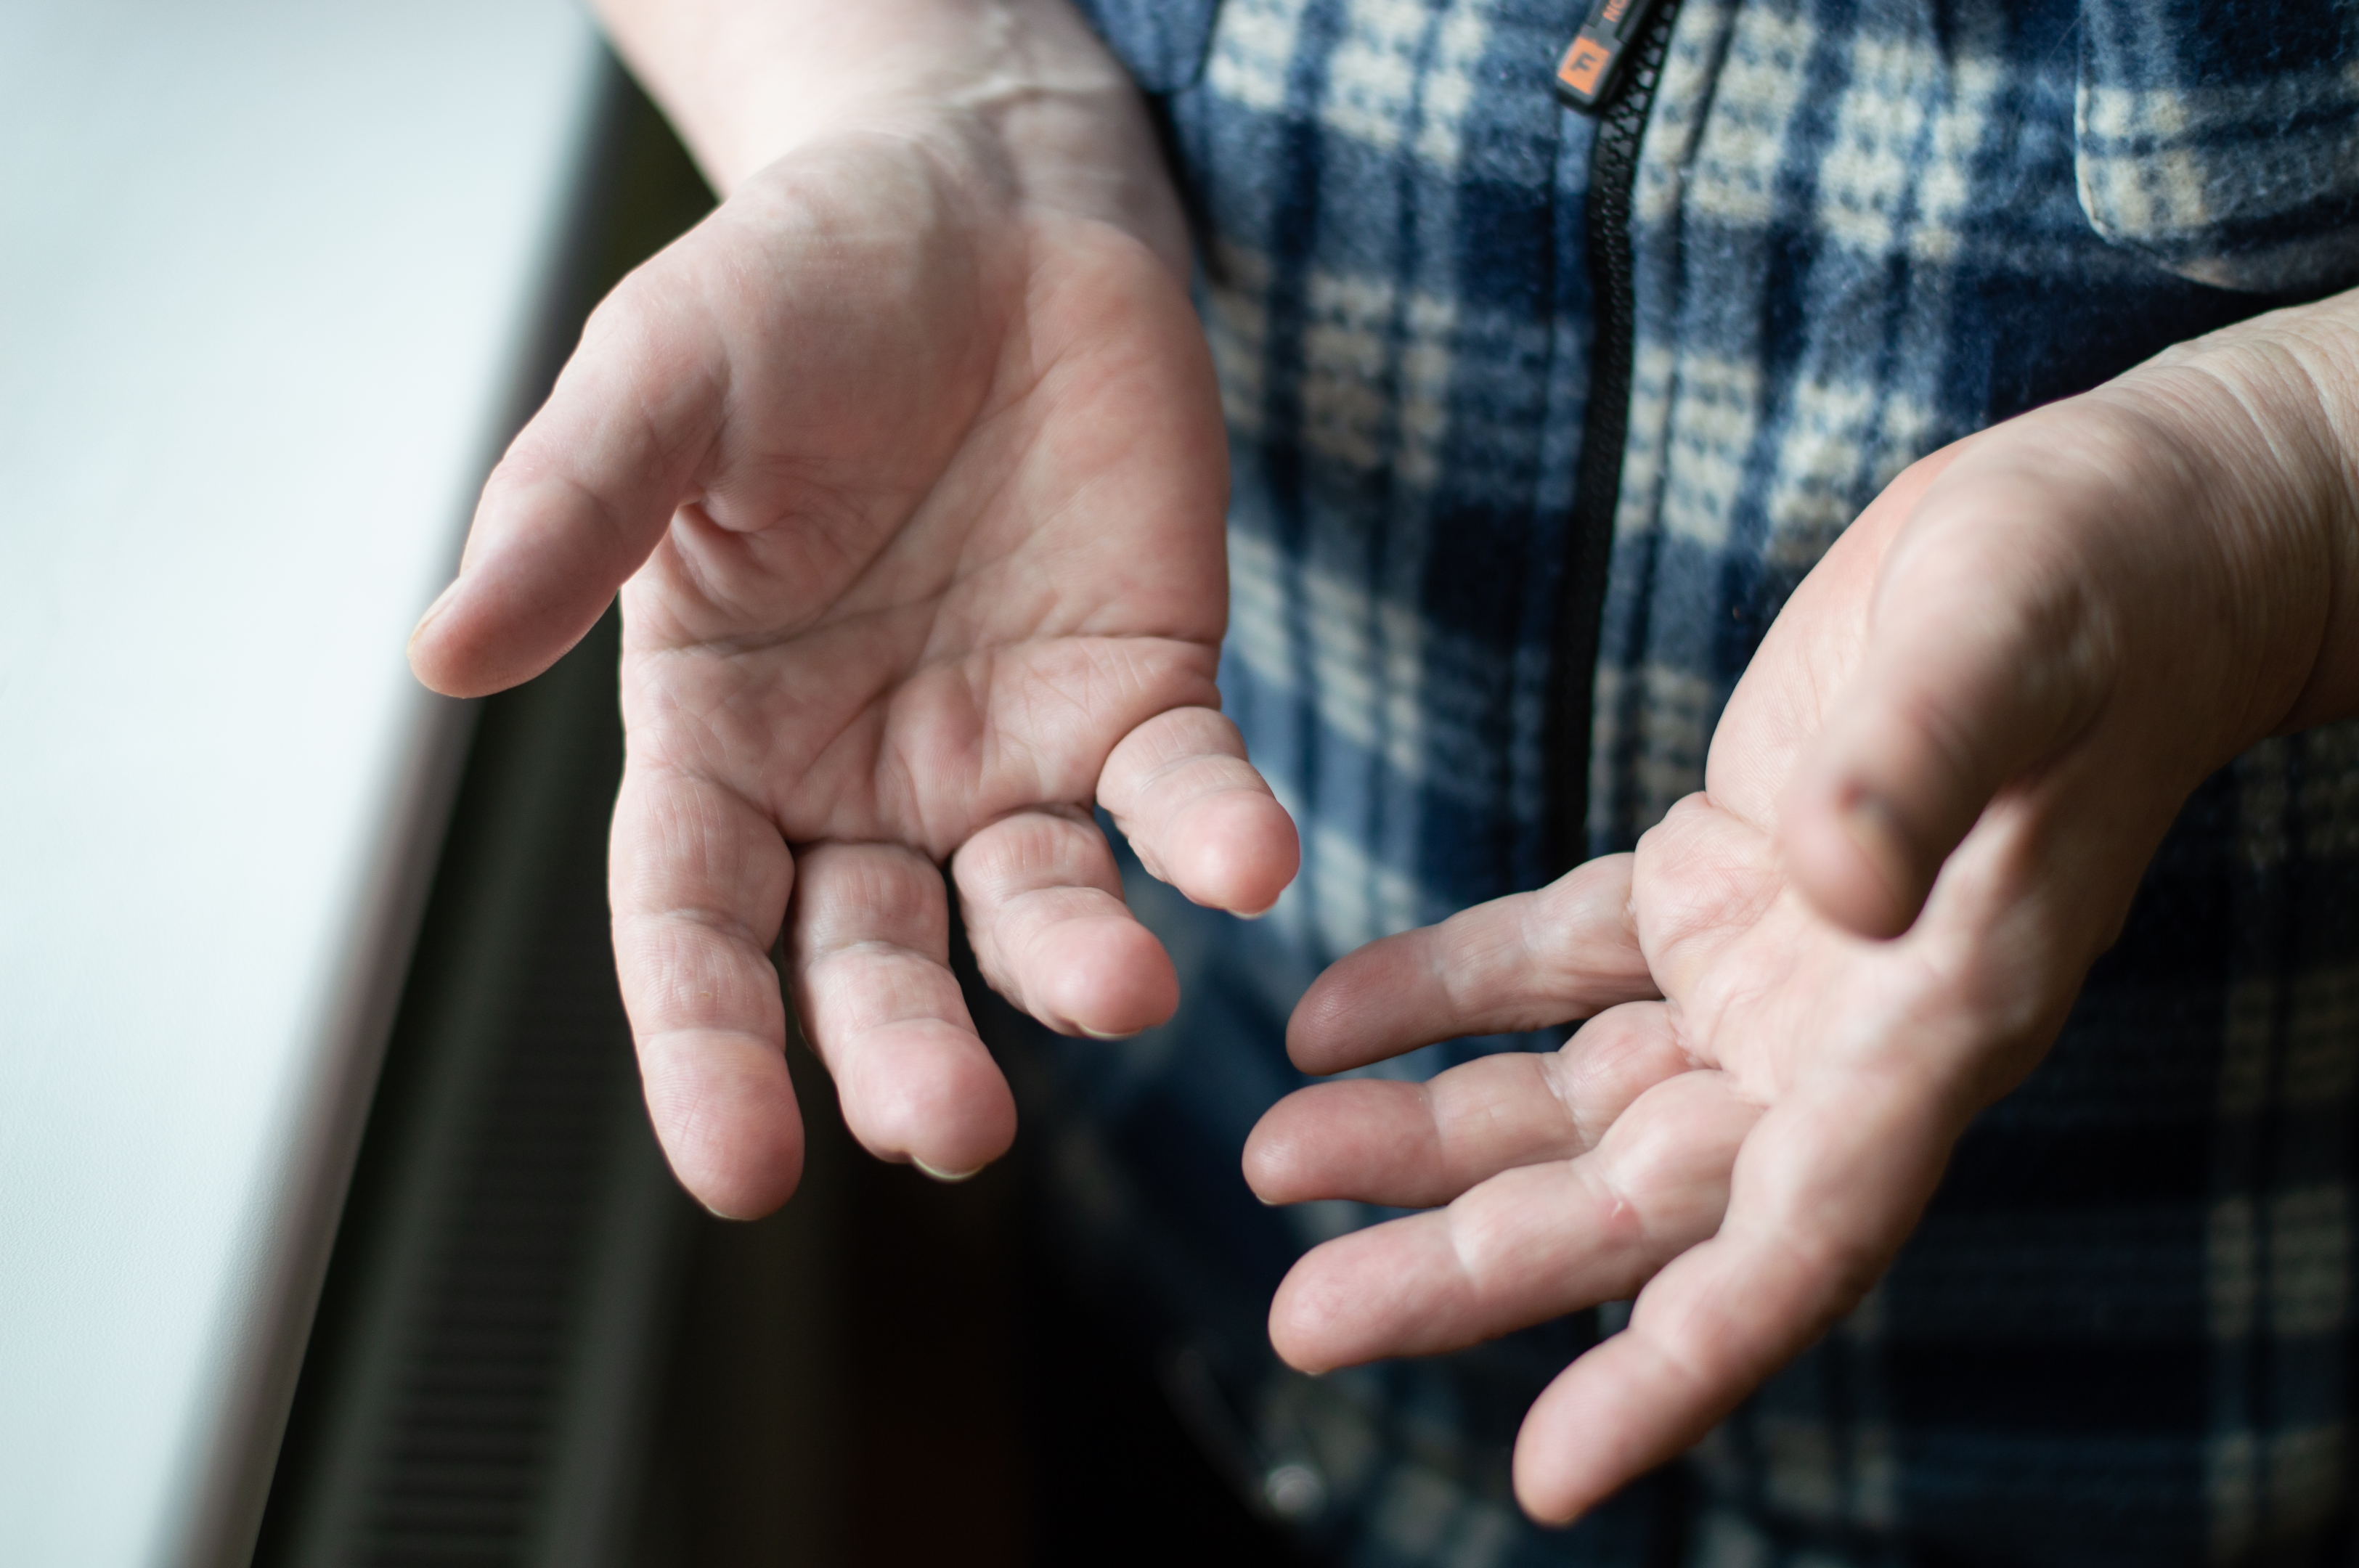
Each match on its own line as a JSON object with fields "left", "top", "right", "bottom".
{"left": 595, "top": 0, "right": 1186, "bottom": 274}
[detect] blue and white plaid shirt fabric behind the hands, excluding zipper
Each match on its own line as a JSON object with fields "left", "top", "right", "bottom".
{"left": 1019, "top": 0, "right": 2359, "bottom": 1568}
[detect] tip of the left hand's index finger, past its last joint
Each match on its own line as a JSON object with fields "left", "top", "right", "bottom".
{"left": 639, "top": 1030, "right": 802, "bottom": 1219}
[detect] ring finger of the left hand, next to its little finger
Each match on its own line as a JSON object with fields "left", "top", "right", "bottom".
{"left": 950, "top": 809, "right": 1180, "bottom": 1040}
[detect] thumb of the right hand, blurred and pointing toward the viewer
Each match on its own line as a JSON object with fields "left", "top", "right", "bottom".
{"left": 1779, "top": 465, "right": 2114, "bottom": 936}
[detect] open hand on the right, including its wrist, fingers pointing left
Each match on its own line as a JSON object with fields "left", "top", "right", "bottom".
{"left": 1245, "top": 300, "right": 2359, "bottom": 1521}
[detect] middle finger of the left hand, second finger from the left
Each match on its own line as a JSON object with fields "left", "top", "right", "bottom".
{"left": 786, "top": 844, "right": 1016, "bottom": 1181}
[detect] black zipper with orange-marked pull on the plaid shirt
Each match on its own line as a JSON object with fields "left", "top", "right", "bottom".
{"left": 1545, "top": 0, "right": 1679, "bottom": 877}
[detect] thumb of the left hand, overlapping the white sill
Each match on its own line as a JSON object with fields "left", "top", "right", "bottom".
{"left": 410, "top": 253, "right": 724, "bottom": 695}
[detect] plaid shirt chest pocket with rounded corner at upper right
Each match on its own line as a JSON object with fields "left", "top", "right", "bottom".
{"left": 2074, "top": 0, "right": 2359, "bottom": 295}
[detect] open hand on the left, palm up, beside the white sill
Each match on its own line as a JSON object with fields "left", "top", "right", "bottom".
{"left": 413, "top": 4, "right": 1295, "bottom": 1214}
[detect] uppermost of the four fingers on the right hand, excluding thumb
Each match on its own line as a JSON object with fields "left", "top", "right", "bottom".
{"left": 1286, "top": 856, "right": 1658, "bottom": 1073}
